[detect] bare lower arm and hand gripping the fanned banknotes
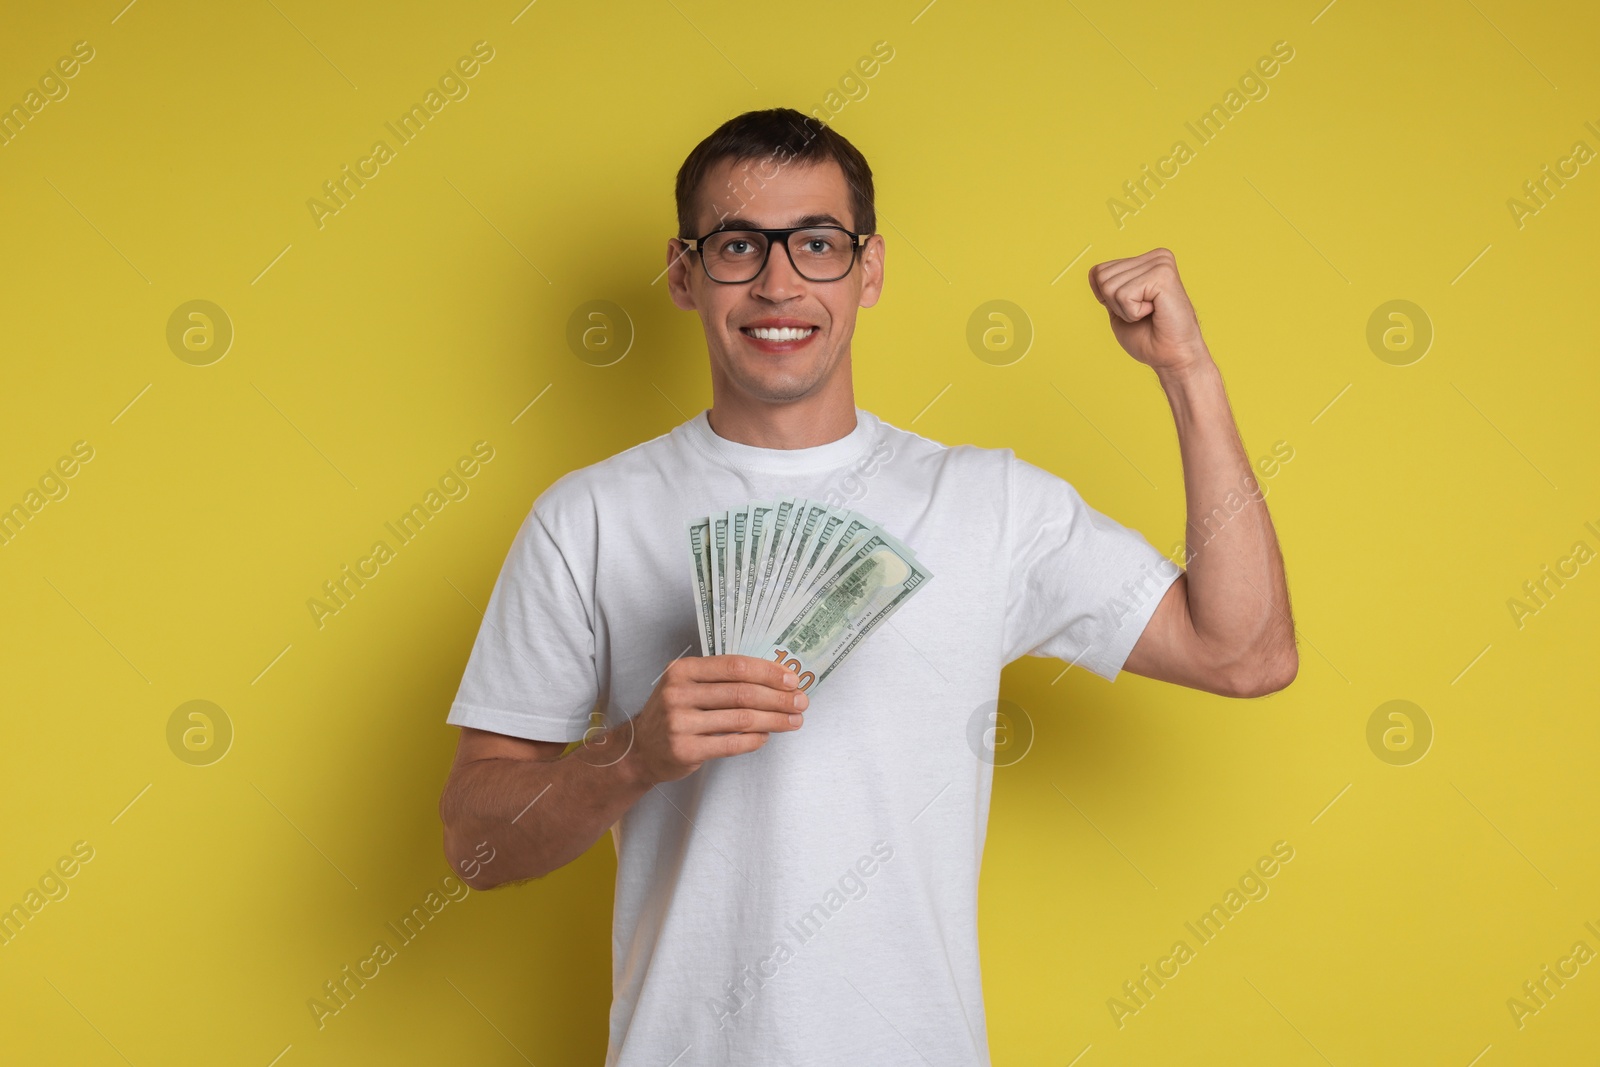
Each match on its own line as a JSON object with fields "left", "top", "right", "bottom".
{"left": 438, "top": 656, "right": 806, "bottom": 889}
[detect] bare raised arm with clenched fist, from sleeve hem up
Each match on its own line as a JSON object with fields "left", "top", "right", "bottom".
{"left": 1090, "top": 248, "right": 1299, "bottom": 696}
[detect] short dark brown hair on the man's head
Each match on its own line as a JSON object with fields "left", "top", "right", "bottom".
{"left": 677, "top": 107, "right": 878, "bottom": 238}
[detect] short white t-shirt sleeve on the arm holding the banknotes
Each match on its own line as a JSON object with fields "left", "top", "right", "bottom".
{"left": 445, "top": 501, "right": 600, "bottom": 741}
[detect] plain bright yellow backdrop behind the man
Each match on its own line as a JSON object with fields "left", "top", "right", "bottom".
{"left": 0, "top": 0, "right": 1600, "bottom": 1067}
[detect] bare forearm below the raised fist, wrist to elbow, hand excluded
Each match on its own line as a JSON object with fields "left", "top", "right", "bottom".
{"left": 1158, "top": 355, "right": 1294, "bottom": 688}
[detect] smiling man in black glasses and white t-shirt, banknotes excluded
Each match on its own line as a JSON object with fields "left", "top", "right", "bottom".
{"left": 440, "top": 109, "right": 1298, "bottom": 1067}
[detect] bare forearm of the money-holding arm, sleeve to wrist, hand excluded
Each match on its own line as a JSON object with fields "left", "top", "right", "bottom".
{"left": 438, "top": 723, "right": 650, "bottom": 889}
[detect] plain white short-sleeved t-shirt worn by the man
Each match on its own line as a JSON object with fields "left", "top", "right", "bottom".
{"left": 448, "top": 408, "right": 1181, "bottom": 1067}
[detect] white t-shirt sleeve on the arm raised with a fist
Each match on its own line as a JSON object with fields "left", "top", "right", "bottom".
{"left": 1005, "top": 450, "right": 1182, "bottom": 681}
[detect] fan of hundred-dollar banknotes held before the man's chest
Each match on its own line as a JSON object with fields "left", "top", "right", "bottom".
{"left": 688, "top": 496, "right": 933, "bottom": 691}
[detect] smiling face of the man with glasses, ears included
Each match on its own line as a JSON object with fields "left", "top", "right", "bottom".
{"left": 667, "top": 160, "right": 883, "bottom": 403}
